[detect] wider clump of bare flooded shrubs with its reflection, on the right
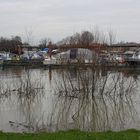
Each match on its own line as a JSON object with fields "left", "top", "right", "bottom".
{"left": 50, "top": 68, "right": 137, "bottom": 131}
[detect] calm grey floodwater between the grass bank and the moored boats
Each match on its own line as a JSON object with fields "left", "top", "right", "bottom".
{"left": 0, "top": 67, "right": 140, "bottom": 132}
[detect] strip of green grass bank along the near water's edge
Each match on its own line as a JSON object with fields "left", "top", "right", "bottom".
{"left": 0, "top": 129, "right": 140, "bottom": 140}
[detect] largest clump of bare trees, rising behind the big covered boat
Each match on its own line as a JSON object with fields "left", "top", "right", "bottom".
{"left": 58, "top": 28, "right": 116, "bottom": 47}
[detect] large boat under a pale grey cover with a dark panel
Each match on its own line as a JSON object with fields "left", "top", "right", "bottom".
{"left": 43, "top": 48, "right": 95, "bottom": 65}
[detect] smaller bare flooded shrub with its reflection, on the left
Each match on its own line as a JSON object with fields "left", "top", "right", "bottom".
{"left": 0, "top": 71, "right": 44, "bottom": 132}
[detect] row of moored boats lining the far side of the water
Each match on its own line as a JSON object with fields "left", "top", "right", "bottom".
{"left": 0, "top": 48, "right": 140, "bottom": 67}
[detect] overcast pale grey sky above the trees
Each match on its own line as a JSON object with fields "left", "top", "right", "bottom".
{"left": 0, "top": 0, "right": 140, "bottom": 42}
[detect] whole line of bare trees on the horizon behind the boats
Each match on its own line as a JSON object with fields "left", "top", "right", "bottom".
{"left": 0, "top": 28, "right": 115, "bottom": 52}
